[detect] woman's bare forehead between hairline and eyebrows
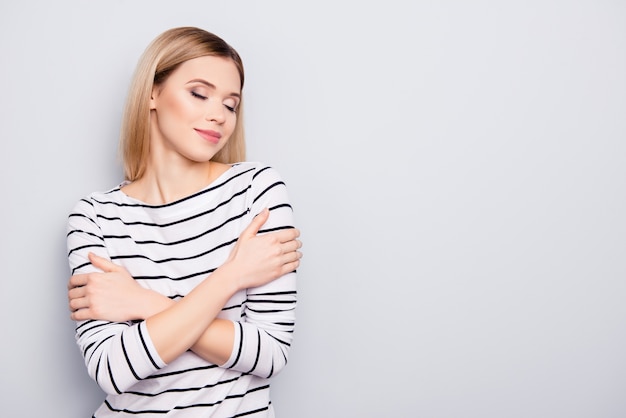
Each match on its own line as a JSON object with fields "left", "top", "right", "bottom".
{"left": 168, "top": 56, "right": 241, "bottom": 93}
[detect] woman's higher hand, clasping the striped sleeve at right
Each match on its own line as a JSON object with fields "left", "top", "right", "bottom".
{"left": 224, "top": 209, "right": 302, "bottom": 290}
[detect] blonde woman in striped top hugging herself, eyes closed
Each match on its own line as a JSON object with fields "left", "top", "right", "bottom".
{"left": 67, "top": 27, "right": 301, "bottom": 417}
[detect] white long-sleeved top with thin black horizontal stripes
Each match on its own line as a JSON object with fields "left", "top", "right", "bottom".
{"left": 67, "top": 162, "right": 296, "bottom": 417}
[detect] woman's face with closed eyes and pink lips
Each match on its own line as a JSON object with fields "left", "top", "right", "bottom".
{"left": 150, "top": 56, "right": 241, "bottom": 162}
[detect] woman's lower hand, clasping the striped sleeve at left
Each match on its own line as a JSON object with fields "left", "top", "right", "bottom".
{"left": 67, "top": 253, "right": 165, "bottom": 322}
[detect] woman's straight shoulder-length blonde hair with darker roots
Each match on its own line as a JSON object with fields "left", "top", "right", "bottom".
{"left": 120, "top": 27, "right": 246, "bottom": 181}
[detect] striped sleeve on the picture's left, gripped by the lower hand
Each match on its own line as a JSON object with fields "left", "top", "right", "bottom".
{"left": 67, "top": 199, "right": 165, "bottom": 394}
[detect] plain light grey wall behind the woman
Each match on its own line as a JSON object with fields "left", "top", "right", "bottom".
{"left": 0, "top": 0, "right": 626, "bottom": 418}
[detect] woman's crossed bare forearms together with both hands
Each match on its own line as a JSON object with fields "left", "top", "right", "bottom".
{"left": 68, "top": 209, "right": 302, "bottom": 364}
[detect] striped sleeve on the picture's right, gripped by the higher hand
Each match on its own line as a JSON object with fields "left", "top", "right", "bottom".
{"left": 223, "top": 167, "right": 296, "bottom": 378}
